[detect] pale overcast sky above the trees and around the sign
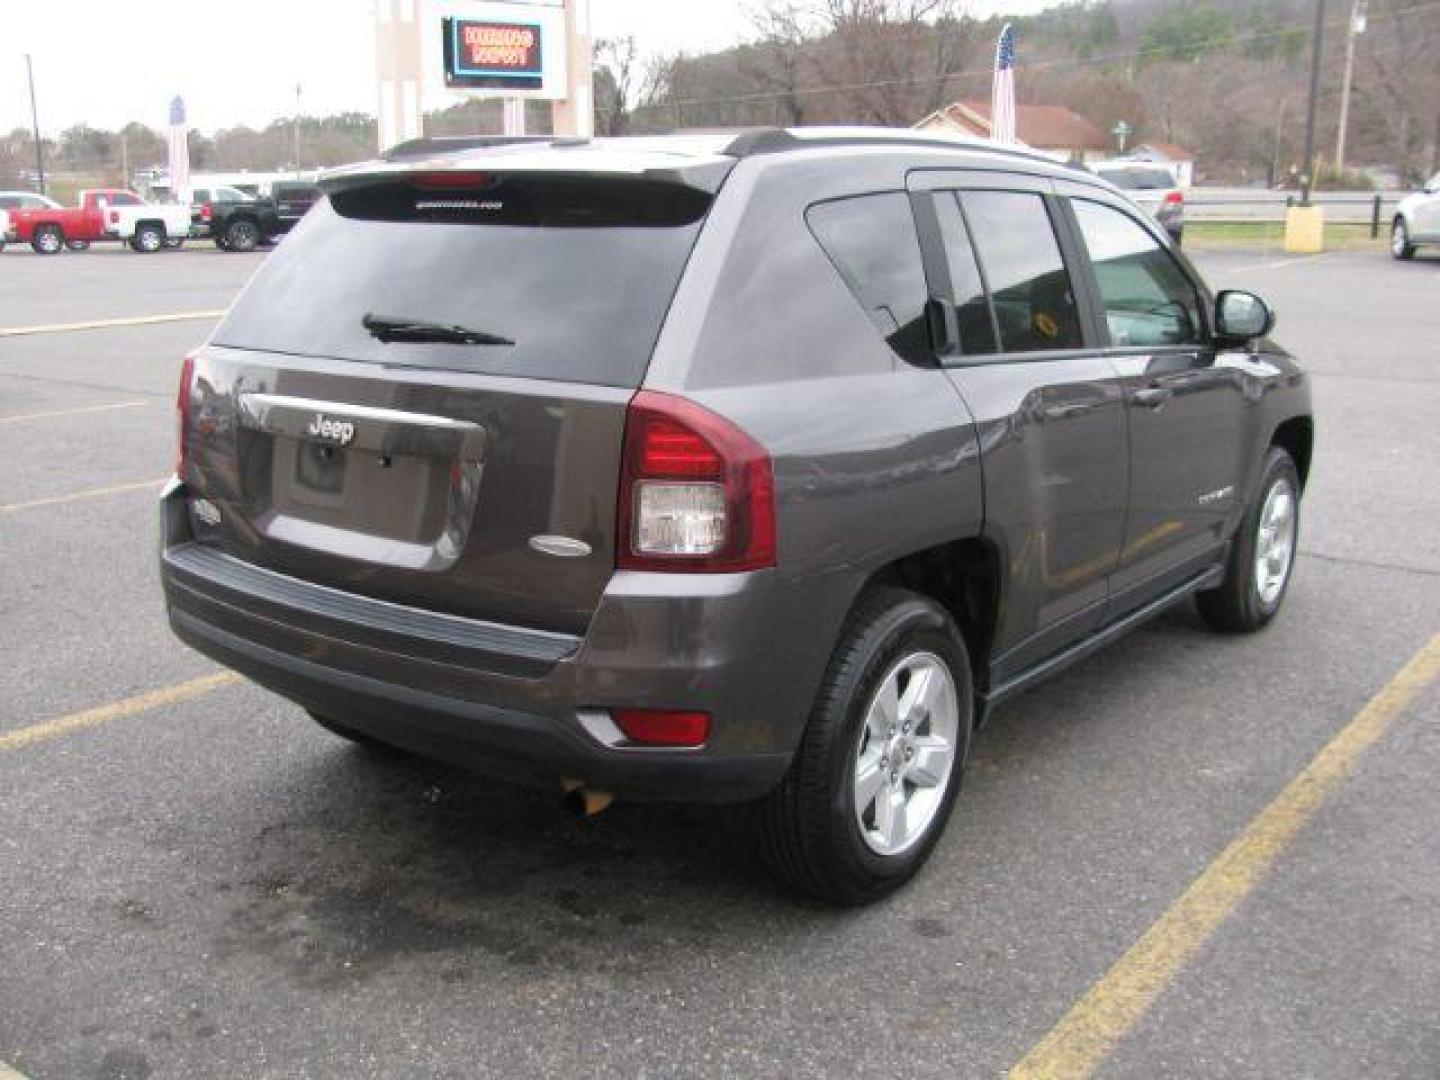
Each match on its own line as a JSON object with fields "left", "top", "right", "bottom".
{"left": 0, "top": 0, "right": 1045, "bottom": 135}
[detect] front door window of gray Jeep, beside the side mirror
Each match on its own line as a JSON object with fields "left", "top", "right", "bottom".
{"left": 1070, "top": 199, "right": 1204, "bottom": 346}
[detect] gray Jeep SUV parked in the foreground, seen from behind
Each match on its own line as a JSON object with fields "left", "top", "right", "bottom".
{"left": 161, "top": 128, "right": 1312, "bottom": 903}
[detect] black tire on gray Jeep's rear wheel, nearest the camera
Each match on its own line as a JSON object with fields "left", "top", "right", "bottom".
{"left": 759, "top": 588, "right": 975, "bottom": 904}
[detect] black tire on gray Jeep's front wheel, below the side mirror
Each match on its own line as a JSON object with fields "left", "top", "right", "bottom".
{"left": 1195, "top": 446, "right": 1300, "bottom": 634}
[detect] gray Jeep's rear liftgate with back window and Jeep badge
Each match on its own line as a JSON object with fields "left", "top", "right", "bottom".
{"left": 190, "top": 173, "right": 710, "bottom": 632}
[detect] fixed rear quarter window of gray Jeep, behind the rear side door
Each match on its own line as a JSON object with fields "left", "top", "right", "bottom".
{"left": 805, "top": 192, "right": 930, "bottom": 363}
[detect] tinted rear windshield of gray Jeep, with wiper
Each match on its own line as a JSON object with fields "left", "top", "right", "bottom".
{"left": 213, "top": 174, "right": 710, "bottom": 386}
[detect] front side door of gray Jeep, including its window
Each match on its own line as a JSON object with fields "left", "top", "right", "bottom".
{"left": 1067, "top": 186, "right": 1250, "bottom": 615}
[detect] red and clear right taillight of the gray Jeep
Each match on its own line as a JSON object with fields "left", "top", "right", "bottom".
{"left": 615, "top": 390, "right": 775, "bottom": 573}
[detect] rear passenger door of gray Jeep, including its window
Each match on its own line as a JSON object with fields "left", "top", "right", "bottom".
{"left": 914, "top": 173, "right": 1126, "bottom": 681}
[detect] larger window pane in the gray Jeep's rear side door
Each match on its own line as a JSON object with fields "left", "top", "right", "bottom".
{"left": 960, "top": 192, "right": 1083, "bottom": 353}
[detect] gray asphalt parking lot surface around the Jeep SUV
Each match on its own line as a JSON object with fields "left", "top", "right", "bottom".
{"left": 0, "top": 246, "right": 1440, "bottom": 1080}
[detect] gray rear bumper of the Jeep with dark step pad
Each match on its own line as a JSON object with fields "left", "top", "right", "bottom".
{"left": 161, "top": 484, "right": 818, "bottom": 802}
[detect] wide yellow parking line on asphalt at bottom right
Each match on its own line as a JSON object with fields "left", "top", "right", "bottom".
{"left": 1009, "top": 634, "right": 1440, "bottom": 1080}
